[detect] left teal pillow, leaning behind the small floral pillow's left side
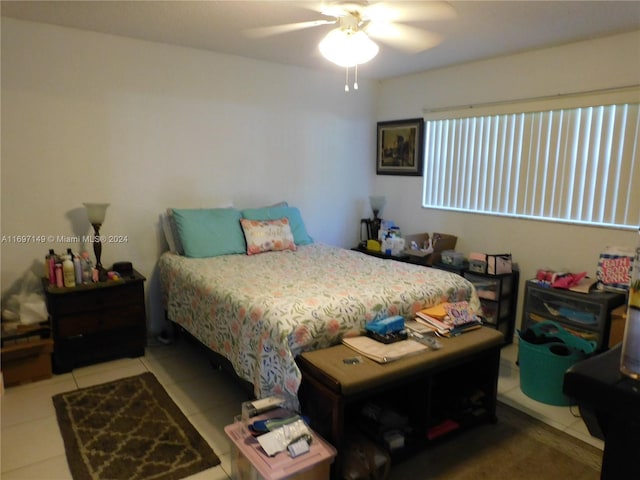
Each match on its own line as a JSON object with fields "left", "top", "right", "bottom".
{"left": 173, "top": 208, "right": 247, "bottom": 258}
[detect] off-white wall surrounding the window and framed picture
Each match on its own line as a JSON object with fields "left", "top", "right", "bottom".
{"left": 374, "top": 32, "right": 640, "bottom": 328}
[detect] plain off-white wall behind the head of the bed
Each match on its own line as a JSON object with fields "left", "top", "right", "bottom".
{"left": 1, "top": 17, "right": 377, "bottom": 329}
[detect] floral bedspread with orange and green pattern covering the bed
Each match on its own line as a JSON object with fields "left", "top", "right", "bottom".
{"left": 159, "top": 243, "right": 480, "bottom": 408}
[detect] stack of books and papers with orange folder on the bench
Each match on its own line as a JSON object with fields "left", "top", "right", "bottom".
{"left": 416, "top": 302, "right": 482, "bottom": 337}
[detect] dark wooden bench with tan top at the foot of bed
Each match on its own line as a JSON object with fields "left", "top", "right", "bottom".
{"left": 297, "top": 327, "right": 504, "bottom": 477}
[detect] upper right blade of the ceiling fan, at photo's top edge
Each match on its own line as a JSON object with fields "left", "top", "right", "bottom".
{"left": 364, "top": 1, "right": 458, "bottom": 22}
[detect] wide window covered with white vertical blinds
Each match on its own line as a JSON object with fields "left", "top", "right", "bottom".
{"left": 423, "top": 95, "right": 640, "bottom": 228}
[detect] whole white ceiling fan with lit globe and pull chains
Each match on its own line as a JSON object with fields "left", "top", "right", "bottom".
{"left": 245, "top": 1, "right": 456, "bottom": 91}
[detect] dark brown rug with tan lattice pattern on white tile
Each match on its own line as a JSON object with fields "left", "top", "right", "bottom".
{"left": 53, "top": 373, "right": 220, "bottom": 480}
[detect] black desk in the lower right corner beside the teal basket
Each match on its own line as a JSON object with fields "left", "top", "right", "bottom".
{"left": 563, "top": 345, "right": 640, "bottom": 480}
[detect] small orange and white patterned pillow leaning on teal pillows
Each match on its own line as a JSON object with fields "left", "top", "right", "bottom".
{"left": 240, "top": 217, "right": 296, "bottom": 255}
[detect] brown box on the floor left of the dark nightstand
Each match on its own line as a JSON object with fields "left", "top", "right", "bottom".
{"left": 1, "top": 337, "right": 53, "bottom": 387}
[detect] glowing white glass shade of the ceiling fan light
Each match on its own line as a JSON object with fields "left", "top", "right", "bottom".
{"left": 319, "top": 28, "right": 379, "bottom": 67}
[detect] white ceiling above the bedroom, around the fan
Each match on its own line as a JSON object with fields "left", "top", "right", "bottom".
{"left": 1, "top": 0, "right": 640, "bottom": 78}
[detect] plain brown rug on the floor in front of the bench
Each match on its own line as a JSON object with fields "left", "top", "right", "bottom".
{"left": 390, "top": 403, "right": 602, "bottom": 480}
